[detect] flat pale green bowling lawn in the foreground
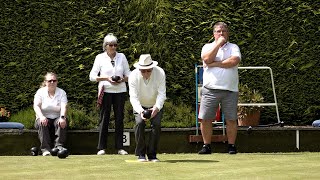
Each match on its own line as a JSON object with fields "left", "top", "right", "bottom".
{"left": 0, "top": 152, "right": 320, "bottom": 180}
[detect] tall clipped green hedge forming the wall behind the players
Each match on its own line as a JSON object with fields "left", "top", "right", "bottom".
{"left": 0, "top": 0, "right": 320, "bottom": 124}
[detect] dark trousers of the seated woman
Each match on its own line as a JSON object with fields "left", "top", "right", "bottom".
{"left": 35, "top": 118, "right": 67, "bottom": 151}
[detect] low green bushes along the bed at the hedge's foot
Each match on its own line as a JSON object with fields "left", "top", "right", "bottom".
{"left": 10, "top": 101, "right": 195, "bottom": 130}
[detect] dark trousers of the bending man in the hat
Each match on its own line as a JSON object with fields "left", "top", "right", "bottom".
{"left": 134, "top": 110, "right": 163, "bottom": 157}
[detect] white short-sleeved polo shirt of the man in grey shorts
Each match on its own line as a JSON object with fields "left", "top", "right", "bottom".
{"left": 201, "top": 42, "right": 241, "bottom": 92}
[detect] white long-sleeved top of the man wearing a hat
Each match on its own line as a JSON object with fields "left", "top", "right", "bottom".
{"left": 129, "top": 66, "right": 166, "bottom": 113}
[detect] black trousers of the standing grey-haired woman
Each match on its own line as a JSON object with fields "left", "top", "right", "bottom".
{"left": 97, "top": 93, "right": 126, "bottom": 150}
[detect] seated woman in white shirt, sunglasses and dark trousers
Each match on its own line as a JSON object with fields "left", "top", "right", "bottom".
{"left": 33, "top": 72, "right": 68, "bottom": 156}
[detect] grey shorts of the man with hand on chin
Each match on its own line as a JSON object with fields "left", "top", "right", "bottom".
{"left": 198, "top": 87, "right": 239, "bottom": 120}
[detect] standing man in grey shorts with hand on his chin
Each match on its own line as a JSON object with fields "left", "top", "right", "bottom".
{"left": 199, "top": 22, "right": 241, "bottom": 154}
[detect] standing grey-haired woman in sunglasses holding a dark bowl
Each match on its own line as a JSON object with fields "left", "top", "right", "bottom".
{"left": 90, "top": 33, "right": 130, "bottom": 155}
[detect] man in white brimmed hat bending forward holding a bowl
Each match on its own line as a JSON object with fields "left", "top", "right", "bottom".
{"left": 129, "top": 54, "right": 166, "bottom": 162}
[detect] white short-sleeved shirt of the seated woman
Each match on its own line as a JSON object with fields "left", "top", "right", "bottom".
{"left": 33, "top": 87, "right": 68, "bottom": 119}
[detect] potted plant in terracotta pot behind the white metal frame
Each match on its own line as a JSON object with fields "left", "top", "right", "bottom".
{"left": 238, "top": 84, "right": 264, "bottom": 126}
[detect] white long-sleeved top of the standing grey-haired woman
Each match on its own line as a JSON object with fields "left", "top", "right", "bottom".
{"left": 89, "top": 52, "right": 130, "bottom": 93}
